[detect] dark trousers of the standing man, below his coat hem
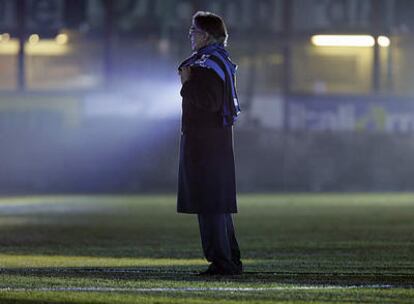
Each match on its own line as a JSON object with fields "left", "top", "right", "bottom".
{"left": 198, "top": 213, "right": 242, "bottom": 271}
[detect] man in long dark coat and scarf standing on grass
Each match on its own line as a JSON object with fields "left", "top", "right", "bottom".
{"left": 177, "top": 12, "right": 243, "bottom": 275}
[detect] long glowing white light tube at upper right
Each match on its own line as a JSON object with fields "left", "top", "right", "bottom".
{"left": 311, "top": 35, "right": 375, "bottom": 47}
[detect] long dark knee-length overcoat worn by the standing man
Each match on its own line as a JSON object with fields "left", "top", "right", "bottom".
{"left": 177, "top": 68, "right": 237, "bottom": 213}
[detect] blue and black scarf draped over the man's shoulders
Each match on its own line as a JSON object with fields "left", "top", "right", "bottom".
{"left": 178, "top": 43, "right": 240, "bottom": 126}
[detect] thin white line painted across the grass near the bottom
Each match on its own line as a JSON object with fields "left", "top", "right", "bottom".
{"left": 0, "top": 285, "right": 393, "bottom": 293}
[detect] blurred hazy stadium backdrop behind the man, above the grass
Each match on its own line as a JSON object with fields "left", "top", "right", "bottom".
{"left": 0, "top": 0, "right": 414, "bottom": 194}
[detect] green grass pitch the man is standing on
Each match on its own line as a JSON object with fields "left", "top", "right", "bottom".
{"left": 0, "top": 193, "right": 414, "bottom": 304}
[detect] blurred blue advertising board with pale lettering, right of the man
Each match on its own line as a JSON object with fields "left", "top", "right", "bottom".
{"left": 286, "top": 96, "right": 414, "bottom": 133}
